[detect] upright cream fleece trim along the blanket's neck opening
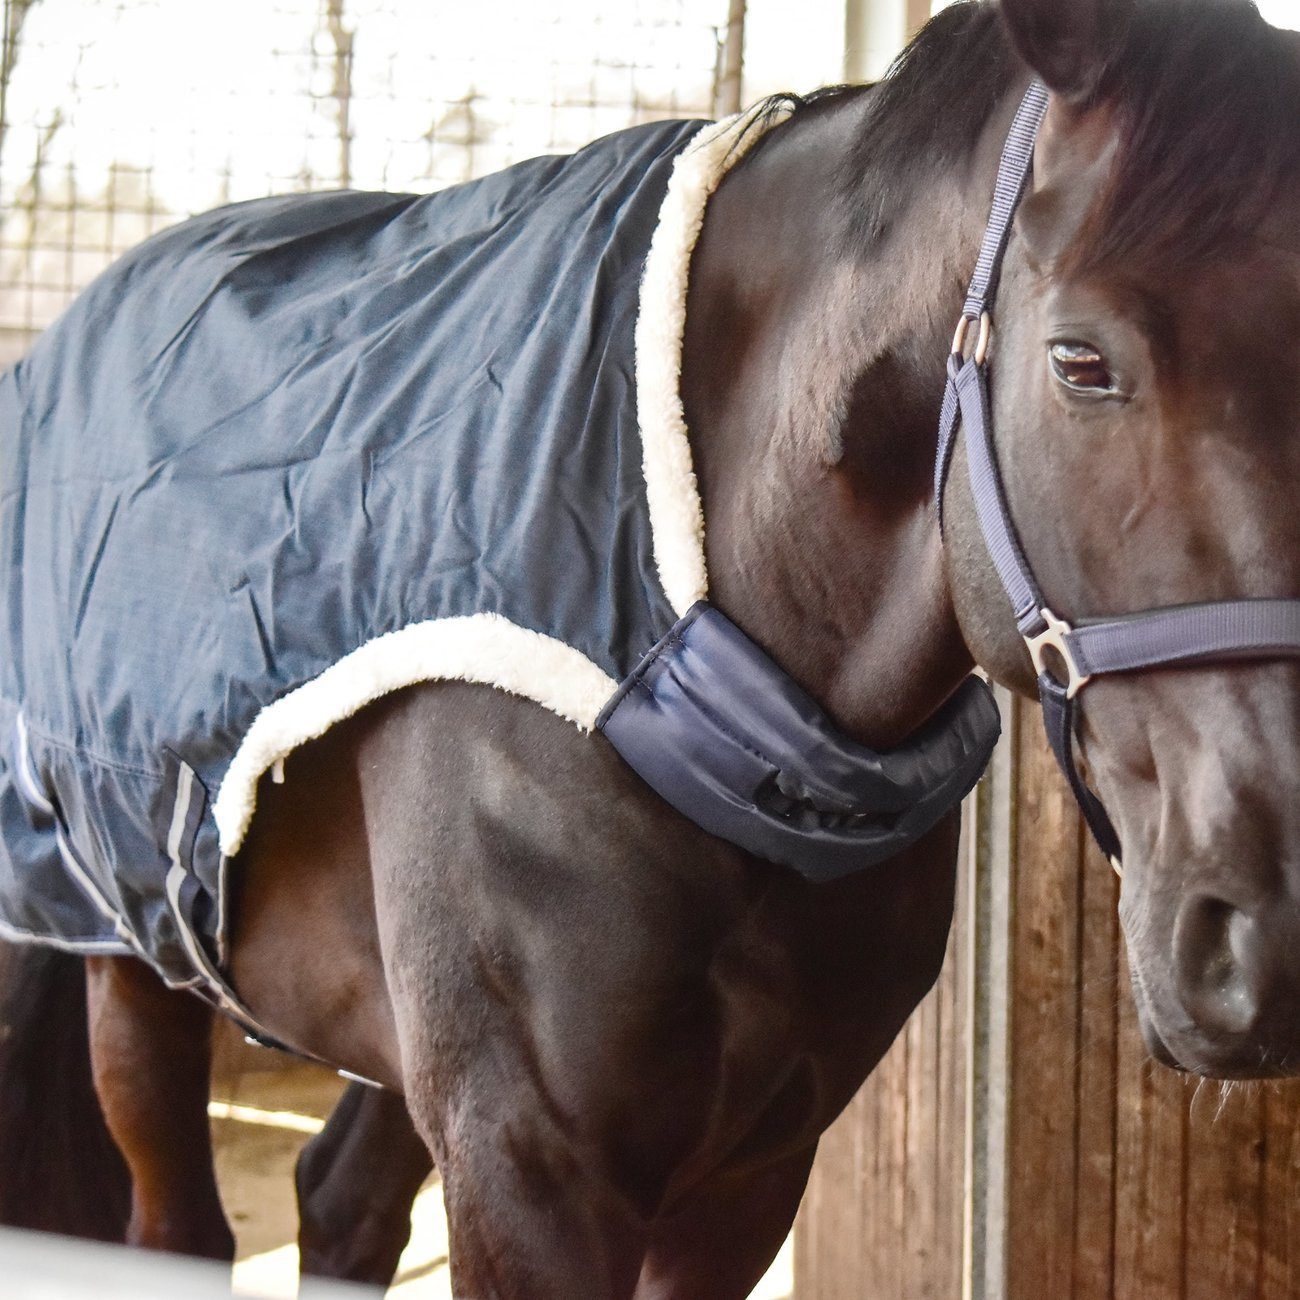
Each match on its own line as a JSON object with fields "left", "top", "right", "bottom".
{"left": 637, "top": 107, "right": 789, "bottom": 618}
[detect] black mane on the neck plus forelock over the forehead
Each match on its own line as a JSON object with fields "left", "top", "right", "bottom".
{"left": 755, "top": 0, "right": 1300, "bottom": 270}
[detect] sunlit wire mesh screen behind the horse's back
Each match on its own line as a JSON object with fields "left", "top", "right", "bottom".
{"left": 0, "top": 0, "right": 744, "bottom": 364}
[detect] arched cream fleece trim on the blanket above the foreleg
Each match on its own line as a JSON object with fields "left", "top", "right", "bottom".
{"left": 212, "top": 614, "right": 618, "bottom": 857}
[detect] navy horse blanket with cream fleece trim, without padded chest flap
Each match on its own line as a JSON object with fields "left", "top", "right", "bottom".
{"left": 0, "top": 114, "right": 761, "bottom": 985}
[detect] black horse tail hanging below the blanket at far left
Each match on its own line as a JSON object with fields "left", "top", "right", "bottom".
{"left": 0, "top": 941, "right": 130, "bottom": 1242}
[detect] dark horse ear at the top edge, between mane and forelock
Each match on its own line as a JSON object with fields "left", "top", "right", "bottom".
{"left": 1002, "top": 0, "right": 1134, "bottom": 104}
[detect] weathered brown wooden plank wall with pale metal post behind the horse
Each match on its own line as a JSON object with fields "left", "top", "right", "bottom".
{"left": 796, "top": 707, "right": 1300, "bottom": 1300}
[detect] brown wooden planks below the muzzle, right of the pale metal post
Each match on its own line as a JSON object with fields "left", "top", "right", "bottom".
{"left": 993, "top": 709, "right": 1300, "bottom": 1300}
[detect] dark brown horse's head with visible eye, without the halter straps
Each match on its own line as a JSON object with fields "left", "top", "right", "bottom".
{"left": 945, "top": 0, "right": 1300, "bottom": 1076}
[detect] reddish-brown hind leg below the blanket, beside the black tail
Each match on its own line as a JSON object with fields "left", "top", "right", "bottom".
{"left": 86, "top": 957, "right": 234, "bottom": 1262}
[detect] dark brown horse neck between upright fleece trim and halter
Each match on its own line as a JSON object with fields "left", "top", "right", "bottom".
{"left": 683, "top": 92, "right": 1014, "bottom": 745}
